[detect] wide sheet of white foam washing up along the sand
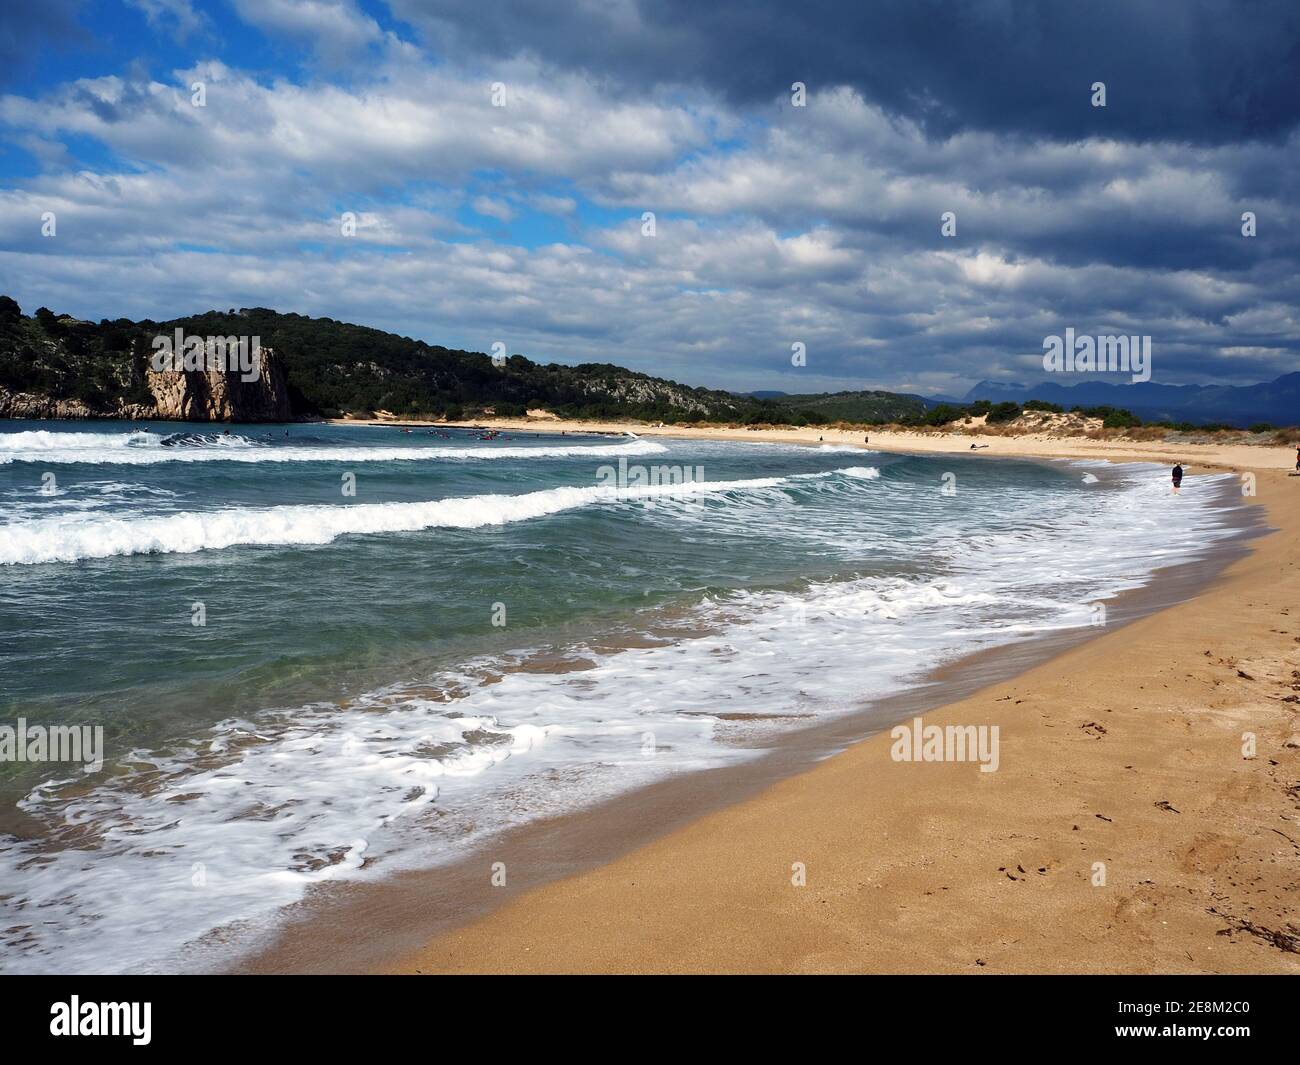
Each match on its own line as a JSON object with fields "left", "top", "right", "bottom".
{"left": 0, "top": 467, "right": 1227, "bottom": 971}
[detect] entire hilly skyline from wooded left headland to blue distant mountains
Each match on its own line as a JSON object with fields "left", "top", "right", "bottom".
{"left": 0, "top": 296, "right": 1300, "bottom": 427}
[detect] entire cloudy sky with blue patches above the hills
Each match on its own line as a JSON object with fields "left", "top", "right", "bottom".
{"left": 0, "top": 0, "right": 1300, "bottom": 395}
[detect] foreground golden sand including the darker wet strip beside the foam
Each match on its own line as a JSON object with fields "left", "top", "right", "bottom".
{"left": 241, "top": 436, "right": 1300, "bottom": 973}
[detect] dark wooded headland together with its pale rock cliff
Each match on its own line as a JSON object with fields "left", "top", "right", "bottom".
{"left": 0, "top": 295, "right": 811, "bottom": 424}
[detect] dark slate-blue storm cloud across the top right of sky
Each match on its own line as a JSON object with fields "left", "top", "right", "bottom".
{"left": 390, "top": 0, "right": 1300, "bottom": 143}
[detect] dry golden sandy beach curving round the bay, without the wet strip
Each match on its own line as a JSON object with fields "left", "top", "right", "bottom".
{"left": 358, "top": 421, "right": 1300, "bottom": 973}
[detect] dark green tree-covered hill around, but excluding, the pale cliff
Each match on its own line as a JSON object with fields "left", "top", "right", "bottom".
{"left": 0, "top": 296, "right": 809, "bottom": 423}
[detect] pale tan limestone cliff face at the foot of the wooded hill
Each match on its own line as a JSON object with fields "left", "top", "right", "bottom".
{"left": 146, "top": 347, "right": 293, "bottom": 421}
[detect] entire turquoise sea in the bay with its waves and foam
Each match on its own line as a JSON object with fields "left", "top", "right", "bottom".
{"left": 0, "top": 423, "right": 1231, "bottom": 971}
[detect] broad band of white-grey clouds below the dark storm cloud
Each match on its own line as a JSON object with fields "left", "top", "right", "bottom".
{"left": 0, "top": 57, "right": 1297, "bottom": 393}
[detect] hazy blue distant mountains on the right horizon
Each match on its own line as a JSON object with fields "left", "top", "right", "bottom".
{"left": 962, "top": 372, "right": 1300, "bottom": 428}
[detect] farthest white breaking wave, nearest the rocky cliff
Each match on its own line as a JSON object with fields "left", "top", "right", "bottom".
{"left": 0, "top": 429, "right": 667, "bottom": 466}
